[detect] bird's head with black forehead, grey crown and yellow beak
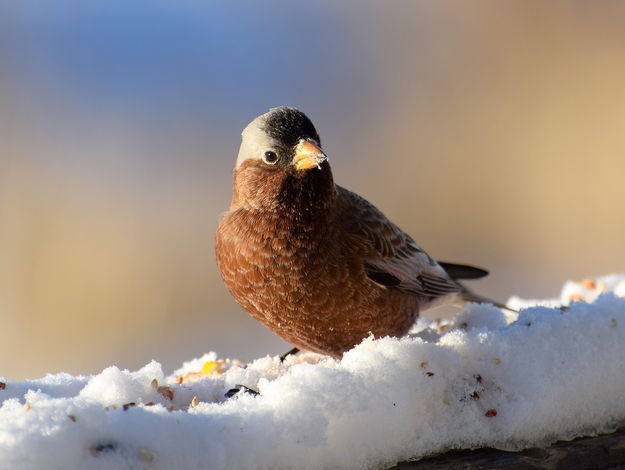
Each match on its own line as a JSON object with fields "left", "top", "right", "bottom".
{"left": 232, "top": 106, "right": 334, "bottom": 209}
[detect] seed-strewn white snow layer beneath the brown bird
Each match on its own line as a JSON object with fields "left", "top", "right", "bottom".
{"left": 0, "top": 275, "right": 625, "bottom": 470}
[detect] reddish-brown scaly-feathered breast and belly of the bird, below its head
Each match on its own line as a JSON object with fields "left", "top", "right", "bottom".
{"left": 215, "top": 172, "right": 419, "bottom": 356}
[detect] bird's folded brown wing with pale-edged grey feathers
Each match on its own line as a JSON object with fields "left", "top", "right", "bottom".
{"left": 338, "top": 187, "right": 464, "bottom": 299}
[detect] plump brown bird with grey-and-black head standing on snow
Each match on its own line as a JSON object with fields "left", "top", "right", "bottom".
{"left": 215, "top": 106, "right": 506, "bottom": 358}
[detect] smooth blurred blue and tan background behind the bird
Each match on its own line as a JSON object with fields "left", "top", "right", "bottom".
{"left": 0, "top": 0, "right": 625, "bottom": 379}
